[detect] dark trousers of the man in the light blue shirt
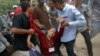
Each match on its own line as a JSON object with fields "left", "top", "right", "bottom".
{"left": 55, "top": 40, "right": 76, "bottom": 56}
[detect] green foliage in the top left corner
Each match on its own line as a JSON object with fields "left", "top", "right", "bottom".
{"left": 0, "top": 0, "right": 19, "bottom": 15}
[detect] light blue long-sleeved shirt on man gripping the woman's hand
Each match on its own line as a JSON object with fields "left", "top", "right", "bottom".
{"left": 58, "top": 4, "right": 86, "bottom": 42}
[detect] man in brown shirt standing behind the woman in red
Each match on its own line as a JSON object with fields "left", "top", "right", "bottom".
{"left": 33, "top": 0, "right": 51, "bottom": 30}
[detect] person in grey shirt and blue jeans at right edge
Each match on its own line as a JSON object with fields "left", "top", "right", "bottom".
{"left": 88, "top": 0, "right": 100, "bottom": 37}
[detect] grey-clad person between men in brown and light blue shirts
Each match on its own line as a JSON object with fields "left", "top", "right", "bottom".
{"left": 48, "top": 1, "right": 59, "bottom": 29}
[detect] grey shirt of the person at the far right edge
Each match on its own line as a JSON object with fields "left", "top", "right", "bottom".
{"left": 88, "top": 0, "right": 100, "bottom": 21}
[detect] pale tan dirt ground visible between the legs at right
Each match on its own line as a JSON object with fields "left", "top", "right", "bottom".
{"left": 61, "top": 33, "right": 100, "bottom": 56}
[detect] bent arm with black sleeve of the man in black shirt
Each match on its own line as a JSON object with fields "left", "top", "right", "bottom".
{"left": 11, "top": 16, "right": 34, "bottom": 34}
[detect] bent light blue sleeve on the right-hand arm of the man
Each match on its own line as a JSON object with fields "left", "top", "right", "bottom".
{"left": 68, "top": 8, "right": 86, "bottom": 26}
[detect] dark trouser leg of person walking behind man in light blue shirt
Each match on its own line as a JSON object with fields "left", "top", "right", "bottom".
{"left": 81, "top": 29, "right": 93, "bottom": 56}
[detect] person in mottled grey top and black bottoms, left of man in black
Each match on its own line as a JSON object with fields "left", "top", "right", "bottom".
{"left": 0, "top": 14, "right": 13, "bottom": 44}
